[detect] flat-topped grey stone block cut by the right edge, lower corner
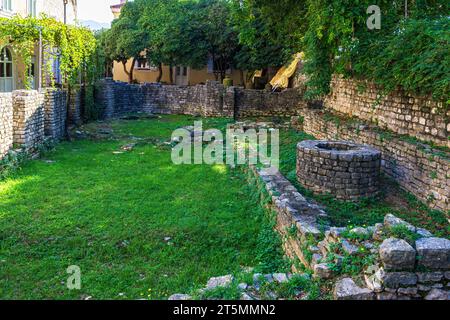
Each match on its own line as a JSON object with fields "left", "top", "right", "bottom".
{"left": 416, "top": 238, "right": 450, "bottom": 270}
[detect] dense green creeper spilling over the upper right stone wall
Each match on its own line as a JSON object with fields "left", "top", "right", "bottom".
{"left": 351, "top": 17, "right": 450, "bottom": 101}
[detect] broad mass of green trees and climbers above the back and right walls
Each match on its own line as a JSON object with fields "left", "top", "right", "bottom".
{"left": 104, "top": 0, "right": 450, "bottom": 101}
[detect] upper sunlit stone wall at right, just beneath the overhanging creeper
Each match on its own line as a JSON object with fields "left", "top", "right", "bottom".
{"left": 325, "top": 76, "right": 450, "bottom": 147}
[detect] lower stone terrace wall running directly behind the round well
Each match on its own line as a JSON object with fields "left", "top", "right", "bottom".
{"left": 299, "top": 109, "right": 450, "bottom": 211}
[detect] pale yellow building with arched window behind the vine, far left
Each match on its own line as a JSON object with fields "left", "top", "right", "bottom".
{"left": 0, "top": 0, "right": 76, "bottom": 92}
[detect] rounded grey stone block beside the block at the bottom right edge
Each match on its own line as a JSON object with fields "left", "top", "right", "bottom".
{"left": 379, "top": 238, "right": 416, "bottom": 270}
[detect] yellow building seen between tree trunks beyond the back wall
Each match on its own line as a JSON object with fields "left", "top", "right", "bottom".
{"left": 111, "top": 0, "right": 245, "bottom": 85}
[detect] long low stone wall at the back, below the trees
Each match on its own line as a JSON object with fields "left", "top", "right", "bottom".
{"left": 96, "top": 79, "right": 303, "bottom": 118}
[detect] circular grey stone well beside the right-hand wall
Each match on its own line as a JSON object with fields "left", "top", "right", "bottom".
{"left": 297, "top": 140, "right": 381, "bottom": 201}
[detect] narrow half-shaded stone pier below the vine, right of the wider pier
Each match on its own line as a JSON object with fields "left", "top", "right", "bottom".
{"left": 44, "top": 88, "right": 67, "bottom": 140}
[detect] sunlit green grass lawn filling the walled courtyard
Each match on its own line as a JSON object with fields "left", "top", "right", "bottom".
{"left": 0, "top": 116, "right": 281, "bottom": 299}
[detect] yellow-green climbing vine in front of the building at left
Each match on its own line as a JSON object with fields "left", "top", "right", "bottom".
{"left": 0, "top": 15, "right": 96, "bottom": 87}
